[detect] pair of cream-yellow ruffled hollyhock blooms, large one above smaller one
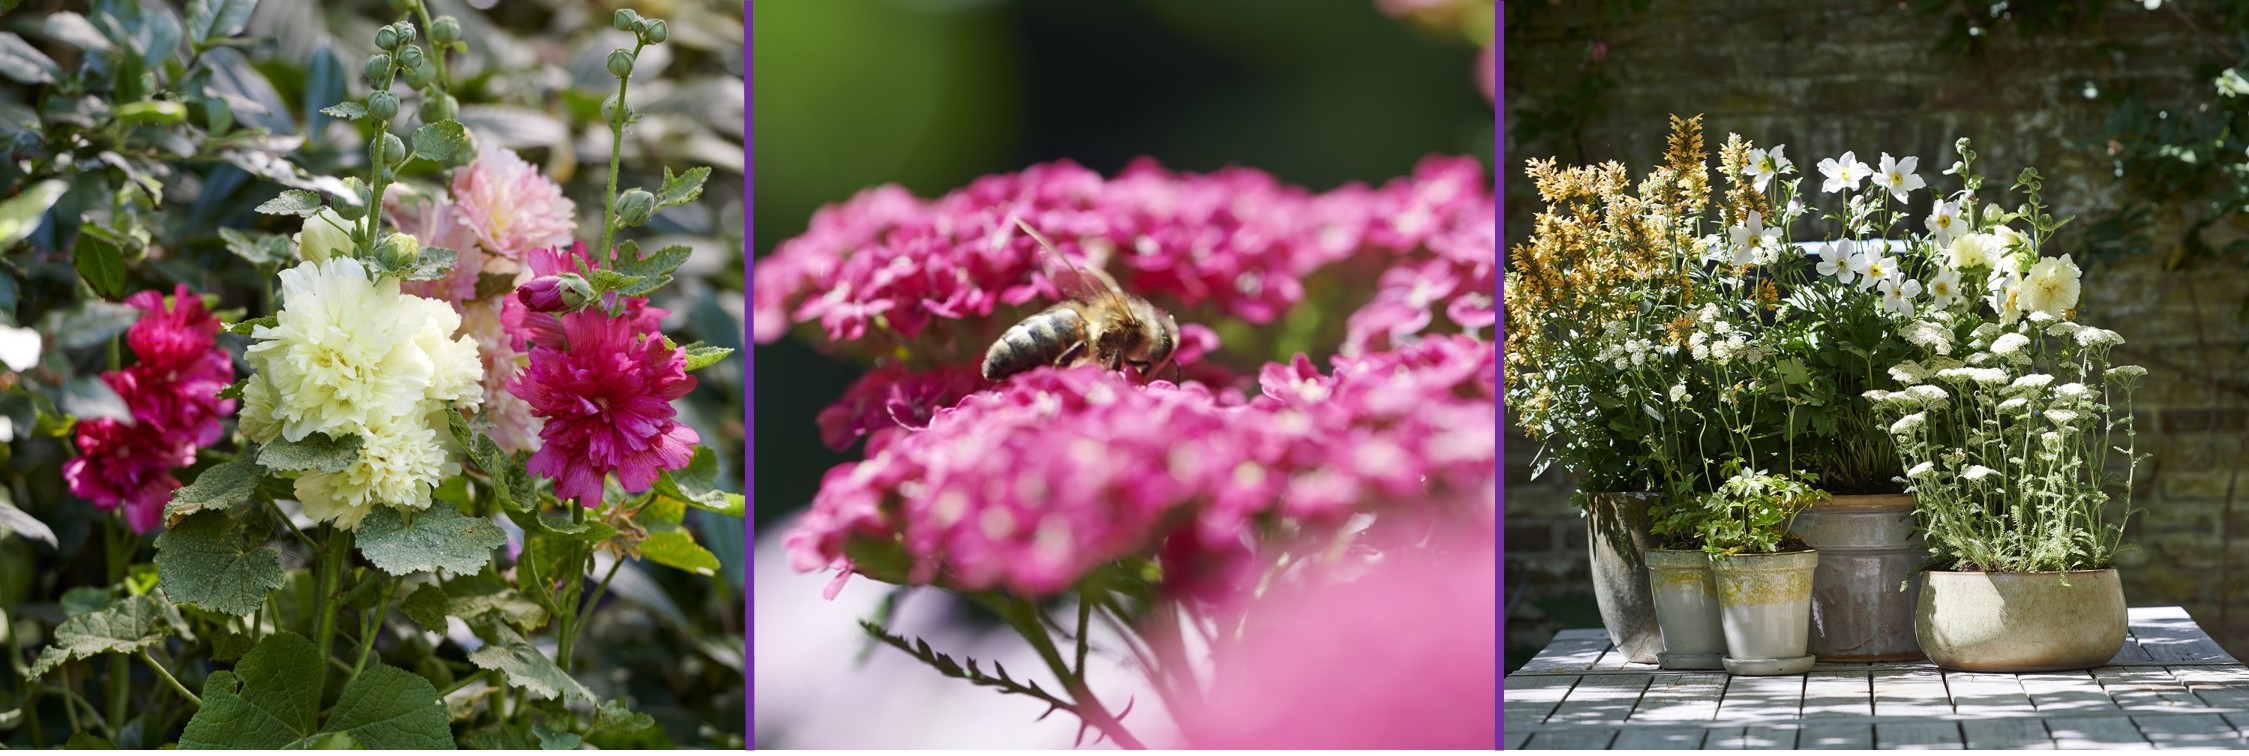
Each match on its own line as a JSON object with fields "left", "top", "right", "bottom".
{"left": 241, "top": 257, "right": 484, "bottom": 527}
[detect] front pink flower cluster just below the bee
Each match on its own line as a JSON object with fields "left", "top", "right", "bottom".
{"left": 787, "top": 335, "right": 1498, "bottom": 596}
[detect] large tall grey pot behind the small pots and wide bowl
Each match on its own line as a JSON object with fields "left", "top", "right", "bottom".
{"left": 1792, "top": 493, "right": 1927, "bottom": 662}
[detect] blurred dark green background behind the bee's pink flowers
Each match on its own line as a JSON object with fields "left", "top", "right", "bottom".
{"left": 751, "top": 0, "right": 1493, "bottom": 529}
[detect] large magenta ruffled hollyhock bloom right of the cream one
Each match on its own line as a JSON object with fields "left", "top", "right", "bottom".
{"left": 508, "top": 311, "right": 702, "bottom": 509}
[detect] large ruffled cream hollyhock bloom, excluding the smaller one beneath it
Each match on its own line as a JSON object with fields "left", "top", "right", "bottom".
{"left": 243, "top": 259, "right": 484, "bottom": 441}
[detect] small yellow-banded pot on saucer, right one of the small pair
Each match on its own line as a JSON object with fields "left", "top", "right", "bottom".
{"left": 1711, "top": 551, "right": 1819, "bottom": 675}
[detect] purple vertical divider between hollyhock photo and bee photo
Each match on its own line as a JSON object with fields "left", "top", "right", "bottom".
{"left": 742, "top": 0, "right": 758, "bottom": 752}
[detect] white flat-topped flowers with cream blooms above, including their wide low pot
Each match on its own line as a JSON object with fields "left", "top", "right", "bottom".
{"left": 1869, "top": 144, "right": 2146, "bottom": 673}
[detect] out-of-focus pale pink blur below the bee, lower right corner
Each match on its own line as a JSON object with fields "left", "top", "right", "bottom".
{"left": 1178, "top": 529, "right": 1498, "bottom": 749}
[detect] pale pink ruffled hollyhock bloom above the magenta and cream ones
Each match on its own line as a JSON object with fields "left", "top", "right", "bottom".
{"left": 452, "top": 144, "right": 578, "bottom": 259}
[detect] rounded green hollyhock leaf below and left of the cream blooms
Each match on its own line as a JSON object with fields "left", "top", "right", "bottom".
{"left": 155, "top": 513, "right": 283, "bottom": 617}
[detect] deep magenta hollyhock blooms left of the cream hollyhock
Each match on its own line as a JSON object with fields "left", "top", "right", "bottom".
{"left": 63, "top": 284, "right": 234, "bottom": 533}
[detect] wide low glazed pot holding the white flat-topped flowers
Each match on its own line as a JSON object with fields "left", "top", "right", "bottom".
{"left": 1914, "top": 569, "right": 2125, "bottom": 673}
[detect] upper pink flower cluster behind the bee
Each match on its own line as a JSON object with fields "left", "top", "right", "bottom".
{"left": 753, "top": 158, "right": 1496, "bottom": 362}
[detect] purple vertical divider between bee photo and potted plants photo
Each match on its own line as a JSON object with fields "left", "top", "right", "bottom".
{"left": 1491, "top": 0, "right": 1507, "bottom": 752}
